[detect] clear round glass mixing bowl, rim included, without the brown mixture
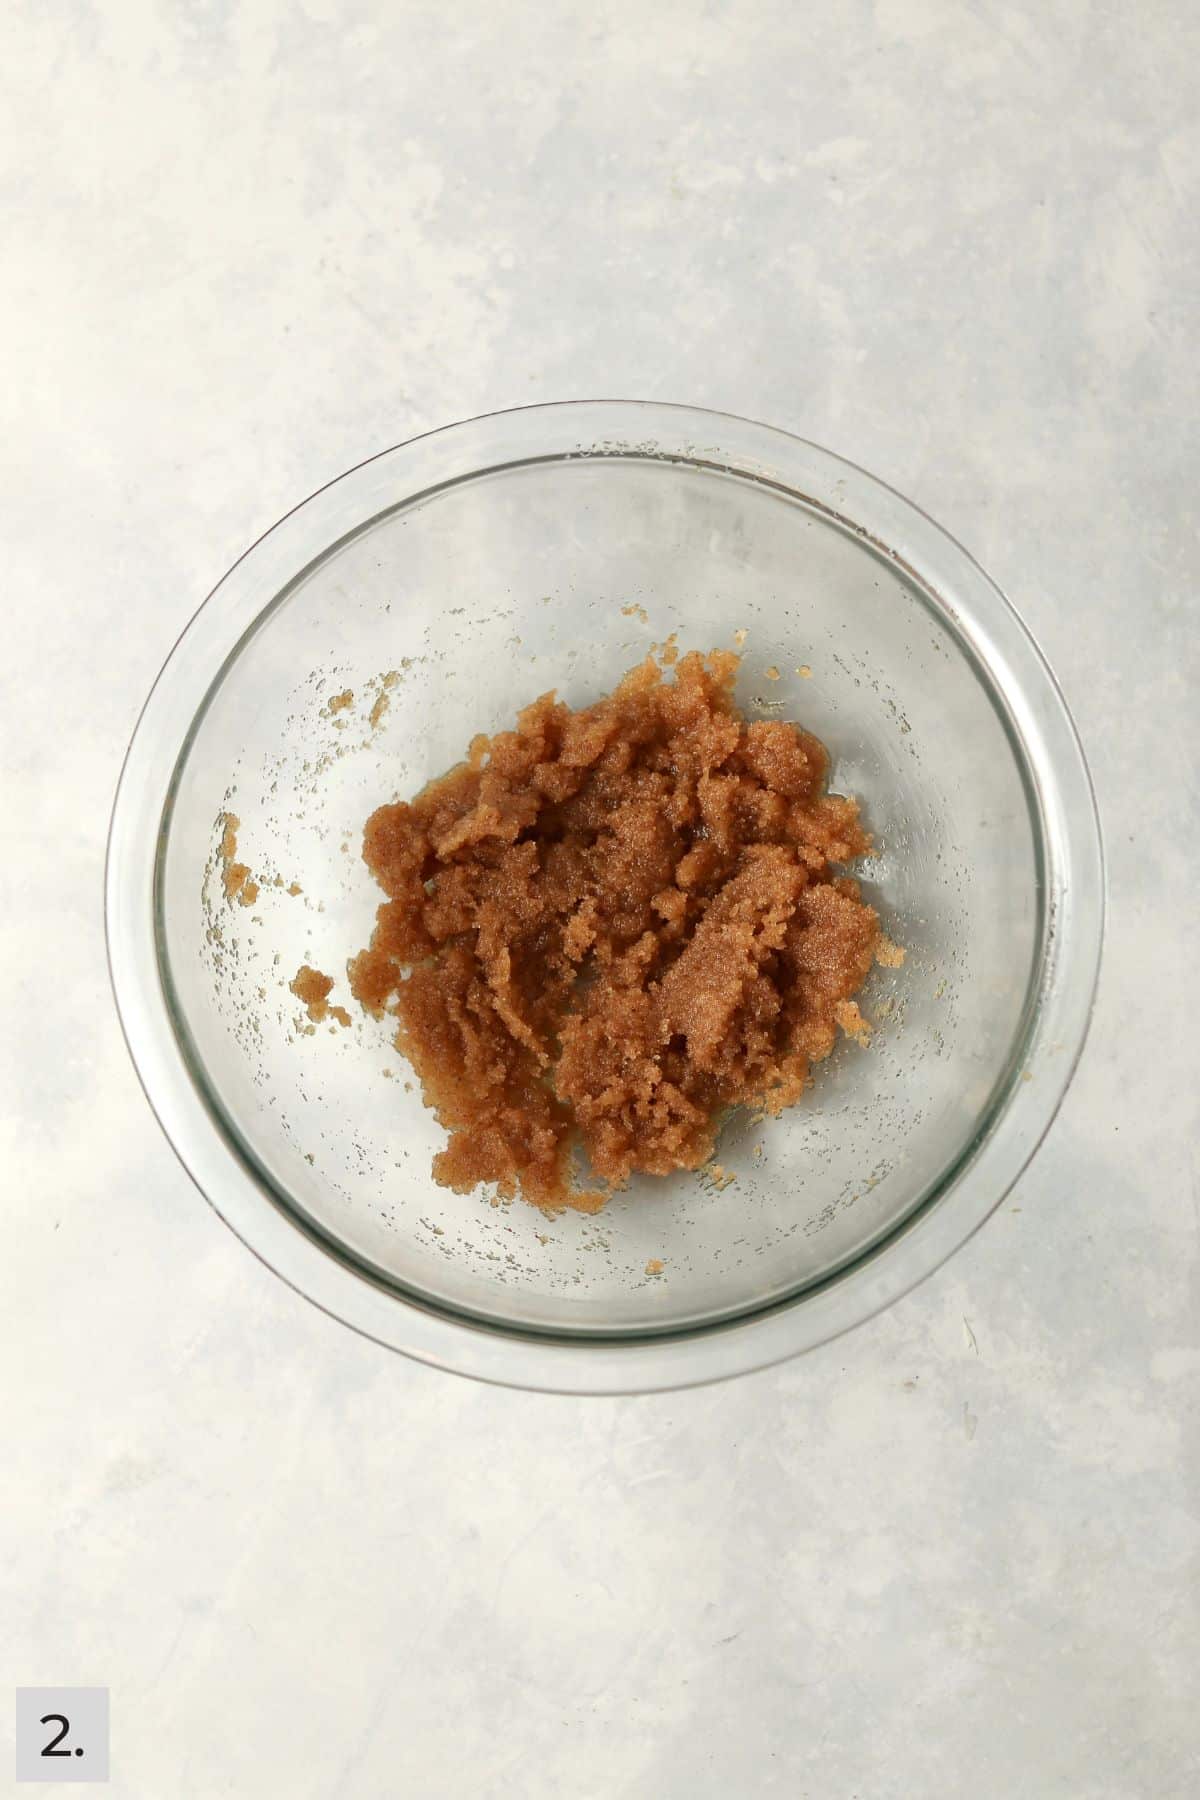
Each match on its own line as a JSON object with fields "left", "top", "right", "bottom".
{"left": 106, "top": 401, "right": 1103, "bottom": 1391}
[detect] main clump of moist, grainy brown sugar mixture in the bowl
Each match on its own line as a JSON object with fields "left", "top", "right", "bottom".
{"left": 351, "top": 652, "right": 885, "bottom": 1210}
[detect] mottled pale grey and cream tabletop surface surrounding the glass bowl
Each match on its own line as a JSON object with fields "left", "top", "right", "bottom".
{"left": 0, "top": 0, "right": 1200, "bottom": 1800}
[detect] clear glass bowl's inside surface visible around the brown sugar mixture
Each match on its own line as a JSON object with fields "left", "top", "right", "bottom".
{"left": 157, "top": 454, "right": 1043, "bottom": 1336}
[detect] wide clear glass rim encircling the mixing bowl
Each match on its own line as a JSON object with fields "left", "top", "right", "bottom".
{"left": 104, "top": 400, "right": 1105, "bottom": 1393}
